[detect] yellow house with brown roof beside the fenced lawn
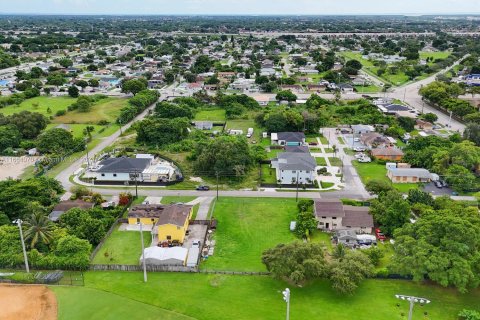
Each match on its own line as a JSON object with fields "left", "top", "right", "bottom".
{"left": 128, "top": 204, "right": 193, "bottom": 243}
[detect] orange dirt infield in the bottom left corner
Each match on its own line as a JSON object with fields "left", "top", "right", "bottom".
{"left": 0, "top": 285, "right": 57, "bottom": 320}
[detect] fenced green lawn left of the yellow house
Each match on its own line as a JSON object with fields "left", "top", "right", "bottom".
{"left": 92, "top": 229, "right": 152, "bottom": 265}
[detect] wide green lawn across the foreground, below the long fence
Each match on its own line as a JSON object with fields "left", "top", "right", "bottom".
{"left": 53, "top": 272, "right": 480, "bottom": 320}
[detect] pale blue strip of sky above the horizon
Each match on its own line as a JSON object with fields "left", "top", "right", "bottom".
{"left": 0, "top": 0, "right": 480, "bottom": 15}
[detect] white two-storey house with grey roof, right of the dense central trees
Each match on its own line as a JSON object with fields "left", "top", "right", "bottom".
{"left": 271, "top": 152, "right": 317, "bottom": 185}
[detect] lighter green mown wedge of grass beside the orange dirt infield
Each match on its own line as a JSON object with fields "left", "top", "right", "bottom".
{"left": 51, "top": 287, "right": 189, "bottom": 320}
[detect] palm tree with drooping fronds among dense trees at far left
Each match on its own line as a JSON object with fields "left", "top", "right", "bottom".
{"left": 24, "top": 211, "right": 53, "bottom": 248}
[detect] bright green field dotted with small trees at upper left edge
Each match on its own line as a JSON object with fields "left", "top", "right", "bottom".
{"left": 0, "top": 96, "right": 77, "bottom": 117}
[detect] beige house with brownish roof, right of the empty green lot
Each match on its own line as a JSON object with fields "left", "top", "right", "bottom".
{"left": 314, "top": 199, "right": 373, "bottom": 233}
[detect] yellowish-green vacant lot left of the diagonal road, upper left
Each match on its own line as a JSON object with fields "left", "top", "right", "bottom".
{"left": 53, "top": 98, "right": 128, "bottom": 123}
